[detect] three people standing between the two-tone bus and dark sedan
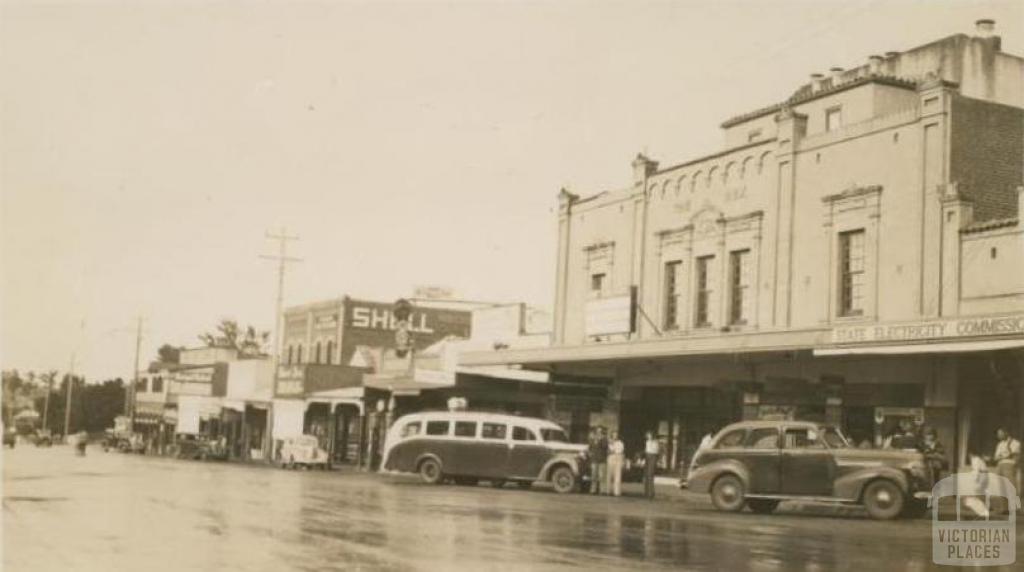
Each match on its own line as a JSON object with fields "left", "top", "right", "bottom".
{"left": 588, "top": 427, "right": 662, "bottom": 498}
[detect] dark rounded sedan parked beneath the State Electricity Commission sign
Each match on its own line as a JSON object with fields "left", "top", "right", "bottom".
{"left": 681, "top": 421, "right": 933, "bottom": 519}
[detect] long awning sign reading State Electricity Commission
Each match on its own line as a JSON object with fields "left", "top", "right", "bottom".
{"left": 831, "top": 314, "right": 1024, "bottom": 344}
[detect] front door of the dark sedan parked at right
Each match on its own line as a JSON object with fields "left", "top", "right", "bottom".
{"left": 780, "top": 427, "right": 836, "bottom": 496}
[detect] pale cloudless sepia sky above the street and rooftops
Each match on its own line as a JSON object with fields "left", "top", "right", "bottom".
{"left": 0, "top": 0, "right": 1024, "bottom": 380}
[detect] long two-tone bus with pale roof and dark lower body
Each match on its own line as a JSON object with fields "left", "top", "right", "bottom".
{"left": 382, "top": 411, "right": 587, "bottom": 493}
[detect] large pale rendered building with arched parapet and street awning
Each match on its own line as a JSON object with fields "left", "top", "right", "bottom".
{"left": 462, "top": 20, "right": 1024, "bottom": 472}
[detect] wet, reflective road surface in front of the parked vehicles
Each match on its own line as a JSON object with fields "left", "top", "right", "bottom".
{"left": 3, "top": 447, "right": 1020, "bottom": 572}
